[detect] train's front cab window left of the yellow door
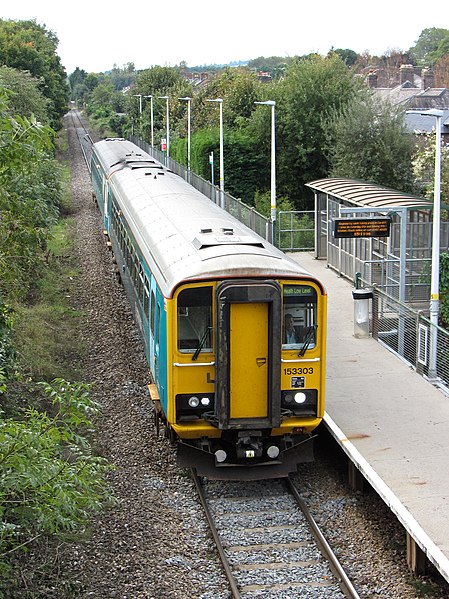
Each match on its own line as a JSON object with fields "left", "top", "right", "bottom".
{"left": 177, "top": 287, "right": 212, "bottom": 360}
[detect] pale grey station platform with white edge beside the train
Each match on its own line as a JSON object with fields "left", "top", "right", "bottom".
{"left": 288, "top": 253, "right": 449, "bottom": 582}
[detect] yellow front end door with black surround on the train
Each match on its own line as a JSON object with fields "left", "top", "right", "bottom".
{"left": 215, "top": 281, "right": 281, "bottom": 429}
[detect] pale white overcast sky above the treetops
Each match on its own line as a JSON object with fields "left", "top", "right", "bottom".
{"left": 0, "top": 0, "right": 449, "bottom": 74}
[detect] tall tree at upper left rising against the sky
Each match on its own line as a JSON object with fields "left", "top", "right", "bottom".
{"left": 0, "top": 20, "right": 68, "bottom": 129}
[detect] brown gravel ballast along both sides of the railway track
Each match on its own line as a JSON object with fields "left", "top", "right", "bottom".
{"left": 11, "top": 110, "right": 449, "bottom": 599}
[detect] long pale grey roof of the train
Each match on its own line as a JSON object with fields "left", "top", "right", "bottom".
{"left": 93, "top": 139, "right": 322, "bottom": 297}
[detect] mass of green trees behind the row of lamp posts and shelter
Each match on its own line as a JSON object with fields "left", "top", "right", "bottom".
{"left": 67, "top": 28, "right": 449, "bottom": 209}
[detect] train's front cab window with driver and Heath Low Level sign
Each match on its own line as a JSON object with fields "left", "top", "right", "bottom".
{"left": 282, "top": 284, "right": 317, "bottom": 353}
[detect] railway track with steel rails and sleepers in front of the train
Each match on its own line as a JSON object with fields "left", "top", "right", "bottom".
{"left": 192, "top": 471, "right": 359, "bottom": 599}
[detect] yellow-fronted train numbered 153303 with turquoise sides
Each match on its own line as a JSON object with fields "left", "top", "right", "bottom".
{"left": 90, "top": 138, "right": 327, "bottom": 480}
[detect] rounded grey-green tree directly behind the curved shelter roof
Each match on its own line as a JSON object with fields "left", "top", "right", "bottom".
{"left": 328, "top": 90, "right": 415, "bottom": 192}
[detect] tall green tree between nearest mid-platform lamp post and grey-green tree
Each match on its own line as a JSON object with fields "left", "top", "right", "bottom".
{"left": 270, "top": 54, "right": 362, "bottom": 209}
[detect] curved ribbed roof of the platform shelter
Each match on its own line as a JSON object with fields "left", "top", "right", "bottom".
{"left": 307, "top": 178, "right": 433, "bottom": 210}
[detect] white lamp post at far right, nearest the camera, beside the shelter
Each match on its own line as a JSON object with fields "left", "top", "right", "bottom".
{"left": 421, "top": 109, "right": 444, "bottom": 379}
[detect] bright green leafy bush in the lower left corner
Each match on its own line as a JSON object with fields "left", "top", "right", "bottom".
{"left": 0, "top": 379, "right": 111, "bottom": 589}
